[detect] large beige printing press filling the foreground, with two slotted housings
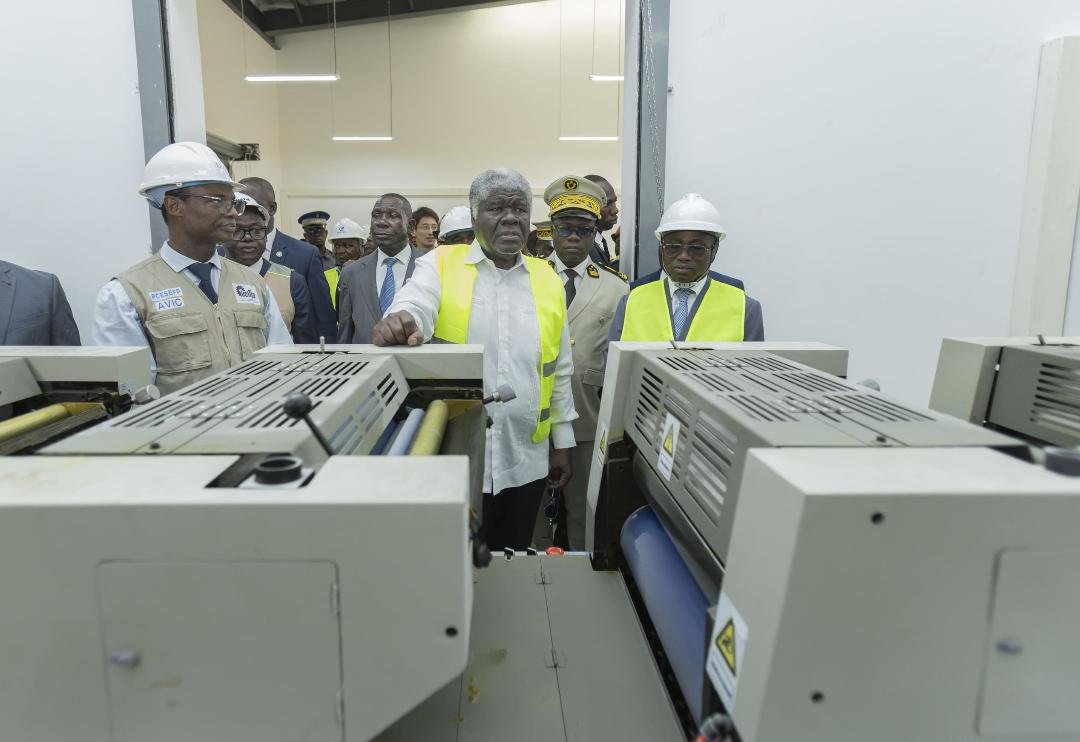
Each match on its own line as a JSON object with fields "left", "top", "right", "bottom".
{"left": 0, "top": 342, "right": 1080, "bottom": 742}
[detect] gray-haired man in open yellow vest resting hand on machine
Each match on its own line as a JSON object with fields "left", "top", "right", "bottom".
{"left": 373, "top": 168, "right": 578, "bottom": 550}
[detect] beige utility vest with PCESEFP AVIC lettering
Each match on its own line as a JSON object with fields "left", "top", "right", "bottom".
{"left": 117, "top": 255, "right": 267, "bottom": 394}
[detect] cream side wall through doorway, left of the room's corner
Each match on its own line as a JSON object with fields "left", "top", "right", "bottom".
{"left": 197, "top": 0, "right": 288, "bottom": 208}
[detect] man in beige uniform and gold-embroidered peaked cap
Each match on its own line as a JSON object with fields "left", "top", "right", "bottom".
{"left": 532, "top": 175, "right": 630, "bottom": 551}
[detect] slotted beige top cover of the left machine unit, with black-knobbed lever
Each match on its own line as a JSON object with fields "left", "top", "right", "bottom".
{"left": 42, "top": 353, "right": 408, "bottom": 462}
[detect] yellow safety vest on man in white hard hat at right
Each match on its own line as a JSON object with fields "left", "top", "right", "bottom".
{"left": 619, "top": 279, "right": 746, "bottom": 342}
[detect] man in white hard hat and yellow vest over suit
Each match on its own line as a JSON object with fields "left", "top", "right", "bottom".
{"left": 608, "top": 193, "right": 765, "bottom": 342}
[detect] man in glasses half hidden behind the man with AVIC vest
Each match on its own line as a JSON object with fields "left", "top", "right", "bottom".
{"left": 224, "top": 193, "right": 319, "bottom": 343}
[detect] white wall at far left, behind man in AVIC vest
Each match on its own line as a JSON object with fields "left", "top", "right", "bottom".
{"left": 0, "top": 0, "right": 150, "bottom": 342}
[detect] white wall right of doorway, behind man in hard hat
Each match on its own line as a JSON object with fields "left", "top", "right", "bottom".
{"left": 666, "top": 0, "right": 1080, "bottom": 404}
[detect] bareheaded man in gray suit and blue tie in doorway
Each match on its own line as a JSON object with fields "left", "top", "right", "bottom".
{"left": 338, "top": 193, "right": 417, "bottom": 343}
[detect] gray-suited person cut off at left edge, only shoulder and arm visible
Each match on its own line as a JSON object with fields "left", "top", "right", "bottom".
{"left": 0, "top": 260, "right": 82, "bottom": 346}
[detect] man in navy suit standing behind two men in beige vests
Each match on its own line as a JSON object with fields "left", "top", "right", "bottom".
{"left": 240, "top": 177, "right": 337, "bottom": 342}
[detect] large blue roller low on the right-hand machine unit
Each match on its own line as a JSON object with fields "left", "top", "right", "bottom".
{"left": 619, "top": 507, "right": 708, "bottom": 723}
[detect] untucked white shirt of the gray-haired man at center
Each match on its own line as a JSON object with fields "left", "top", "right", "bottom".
{"left": 387, "top": 242, "right": 578, "bottom": 495}
